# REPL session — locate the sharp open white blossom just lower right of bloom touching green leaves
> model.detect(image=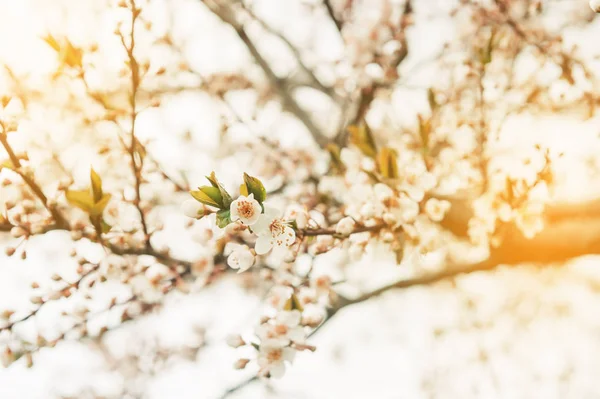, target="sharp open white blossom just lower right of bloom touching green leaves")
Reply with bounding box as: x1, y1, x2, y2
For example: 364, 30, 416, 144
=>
252, 208, 296, 255
